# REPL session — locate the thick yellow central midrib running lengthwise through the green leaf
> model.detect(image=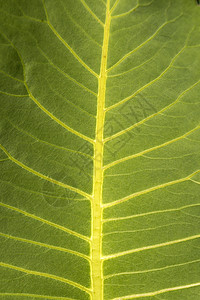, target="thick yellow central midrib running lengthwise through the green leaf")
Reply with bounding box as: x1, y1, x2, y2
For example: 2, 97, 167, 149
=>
91, 0, 111, 300
